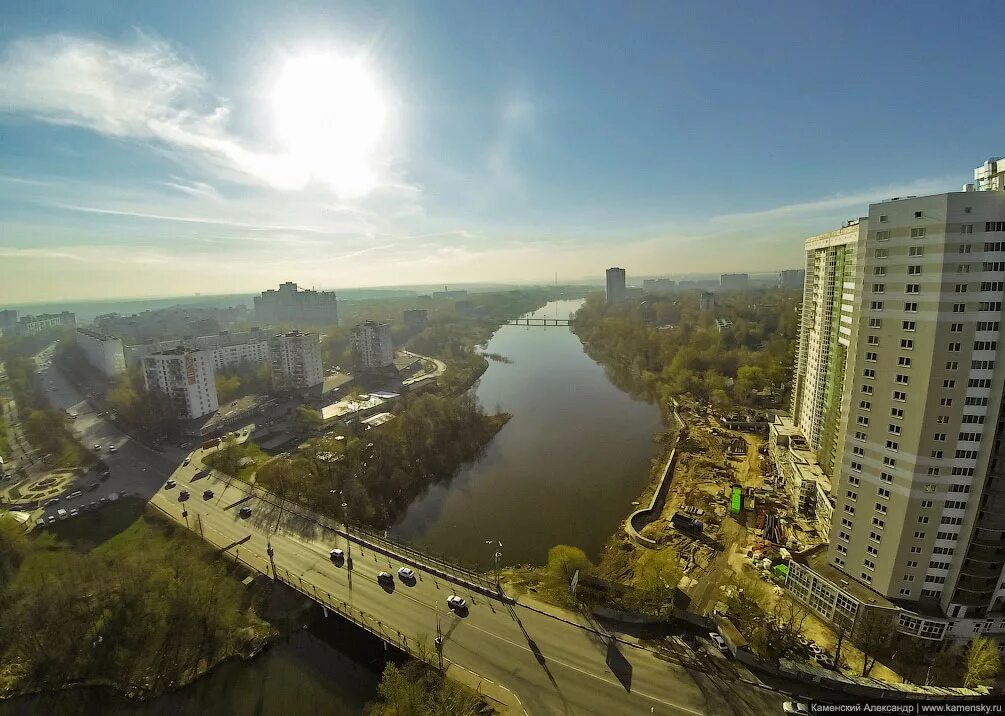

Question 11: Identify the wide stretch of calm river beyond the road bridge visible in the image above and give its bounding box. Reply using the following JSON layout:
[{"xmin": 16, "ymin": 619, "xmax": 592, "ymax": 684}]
[{"xmin": 391, "ymin": 301, "xmax": 661, "ymax": 569}]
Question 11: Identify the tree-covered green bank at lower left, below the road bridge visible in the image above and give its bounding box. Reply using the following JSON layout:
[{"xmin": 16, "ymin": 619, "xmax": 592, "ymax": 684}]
[{"xmin": 0, "ymin": 500, "xmax": 283, "ymax": 697}]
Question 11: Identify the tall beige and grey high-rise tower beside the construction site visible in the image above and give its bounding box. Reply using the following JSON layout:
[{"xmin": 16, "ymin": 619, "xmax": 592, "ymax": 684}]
[{"xmin": 789, "ymin": 170, "xmax": 1005, "ymax": 641}]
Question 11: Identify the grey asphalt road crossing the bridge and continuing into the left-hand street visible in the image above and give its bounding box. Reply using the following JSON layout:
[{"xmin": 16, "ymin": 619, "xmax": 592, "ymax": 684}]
[{"xmin": 44, "ymin": 358, "xmax": 783, "ymax": 716}]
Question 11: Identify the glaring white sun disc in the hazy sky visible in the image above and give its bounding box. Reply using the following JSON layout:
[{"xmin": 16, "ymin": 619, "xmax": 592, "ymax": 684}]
[{"xmin": 272, "ymin": 53, "xmax": 387, "ymax": 197}]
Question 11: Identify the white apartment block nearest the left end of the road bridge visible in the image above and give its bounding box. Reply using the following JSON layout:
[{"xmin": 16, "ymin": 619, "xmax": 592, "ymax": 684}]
[{"xmin": 143, "ymin": 348, "xmax": 220, "ymax": 419}]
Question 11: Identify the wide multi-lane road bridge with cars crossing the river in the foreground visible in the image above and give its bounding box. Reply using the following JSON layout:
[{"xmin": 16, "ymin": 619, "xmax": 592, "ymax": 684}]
[{"xmin": 151, "ymin": 450, "xmax": 782, "ymax": 716}]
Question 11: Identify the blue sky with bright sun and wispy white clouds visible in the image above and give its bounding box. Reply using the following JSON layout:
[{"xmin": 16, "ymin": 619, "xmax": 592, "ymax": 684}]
[{"xmin": 0, "ymin": 0, "xmax": 1005, "ymax": 305}]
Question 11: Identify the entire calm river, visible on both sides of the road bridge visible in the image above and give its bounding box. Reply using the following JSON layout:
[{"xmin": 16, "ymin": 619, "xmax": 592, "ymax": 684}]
[{"xmin": 0, "ymin": 301, "xmax": 661, "ymax": 716}]
